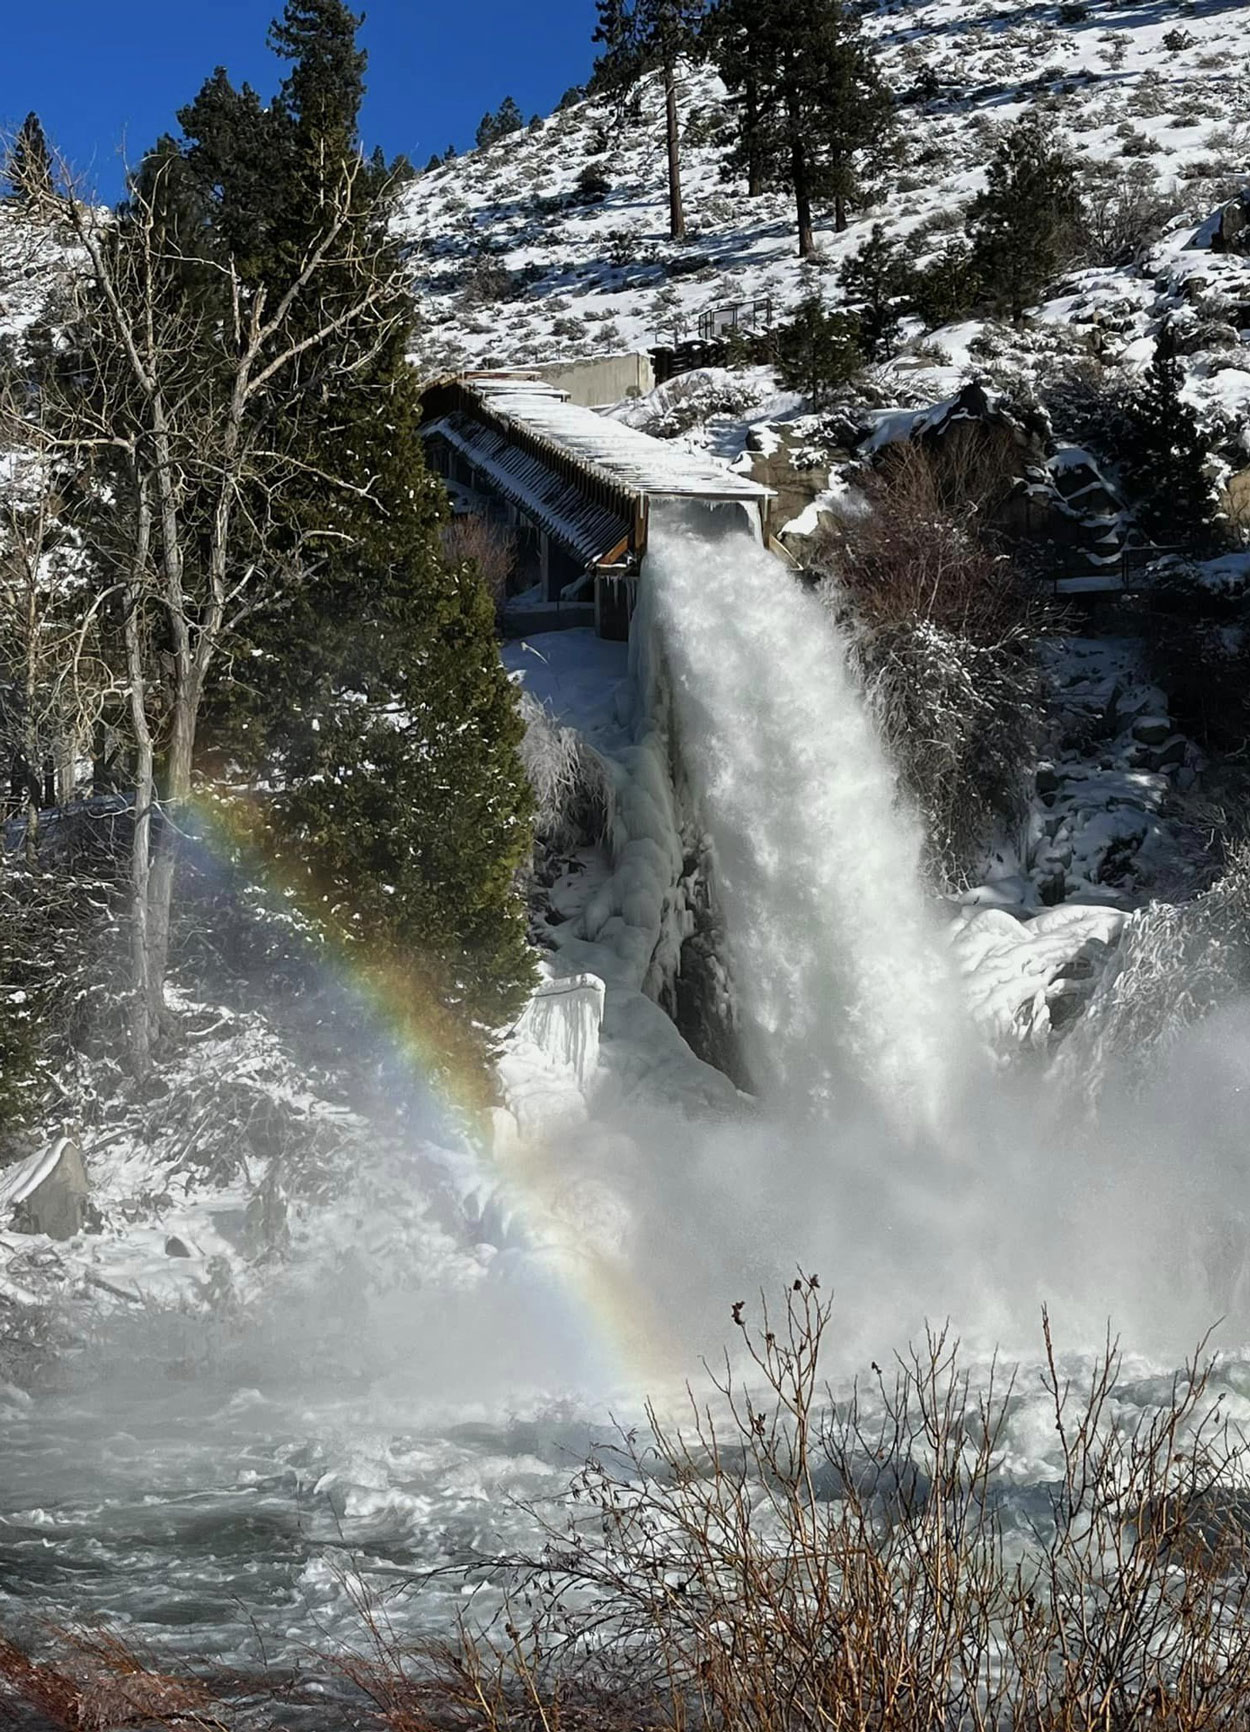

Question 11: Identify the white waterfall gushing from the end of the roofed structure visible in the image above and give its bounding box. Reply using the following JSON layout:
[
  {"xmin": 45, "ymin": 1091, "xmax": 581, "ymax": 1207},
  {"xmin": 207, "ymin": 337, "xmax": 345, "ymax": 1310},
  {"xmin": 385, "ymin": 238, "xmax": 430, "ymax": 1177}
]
[{"xmin": 635, "ymin": 506, "xmax": 971, "ymax": 1131}]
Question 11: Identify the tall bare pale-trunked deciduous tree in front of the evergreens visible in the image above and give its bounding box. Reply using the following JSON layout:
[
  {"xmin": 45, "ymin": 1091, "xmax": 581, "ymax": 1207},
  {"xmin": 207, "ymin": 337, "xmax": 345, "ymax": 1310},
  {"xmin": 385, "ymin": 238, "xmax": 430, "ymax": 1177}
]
[{"xmin": 0, "ymin": 159, "xmax": 413, "ymax": 1072}]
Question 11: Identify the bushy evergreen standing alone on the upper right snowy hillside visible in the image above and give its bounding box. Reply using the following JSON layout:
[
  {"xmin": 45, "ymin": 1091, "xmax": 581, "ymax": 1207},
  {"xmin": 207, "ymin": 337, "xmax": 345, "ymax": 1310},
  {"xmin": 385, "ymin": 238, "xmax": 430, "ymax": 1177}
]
[{"xmin": 968, "ymin": 113, "xmax": 1080, "ymax": 324}]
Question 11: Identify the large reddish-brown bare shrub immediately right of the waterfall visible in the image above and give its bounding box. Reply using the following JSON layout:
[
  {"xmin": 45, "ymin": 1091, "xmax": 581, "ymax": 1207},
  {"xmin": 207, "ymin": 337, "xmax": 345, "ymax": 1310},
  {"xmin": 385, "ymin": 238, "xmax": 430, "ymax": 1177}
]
[{"xmin": 810, "ymin": 438, "xmax": 1041, "ymax": 887}]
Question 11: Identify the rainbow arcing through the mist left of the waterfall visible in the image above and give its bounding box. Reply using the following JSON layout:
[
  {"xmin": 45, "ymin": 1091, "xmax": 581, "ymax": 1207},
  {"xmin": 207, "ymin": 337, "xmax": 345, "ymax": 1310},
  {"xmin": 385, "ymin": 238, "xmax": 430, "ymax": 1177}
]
[{"xmin": 182, "ymin": 792, "xmax": 677, "ymax": 1394}]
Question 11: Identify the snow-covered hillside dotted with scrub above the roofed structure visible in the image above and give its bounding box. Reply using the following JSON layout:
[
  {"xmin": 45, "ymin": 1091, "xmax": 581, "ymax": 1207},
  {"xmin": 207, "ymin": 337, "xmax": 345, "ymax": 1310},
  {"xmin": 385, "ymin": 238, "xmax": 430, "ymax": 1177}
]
[{"xmin": 402, "ymin": 0, "xmax": 1250, "ymax": 456}]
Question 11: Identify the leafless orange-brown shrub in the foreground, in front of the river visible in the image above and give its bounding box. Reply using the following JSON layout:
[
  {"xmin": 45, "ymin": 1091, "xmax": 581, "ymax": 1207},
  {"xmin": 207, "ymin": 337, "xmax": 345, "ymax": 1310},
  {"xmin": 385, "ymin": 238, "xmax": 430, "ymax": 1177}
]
[{"xmin": 322, "ymin": 1278, "xmax": 1250, "ymax": 1732}]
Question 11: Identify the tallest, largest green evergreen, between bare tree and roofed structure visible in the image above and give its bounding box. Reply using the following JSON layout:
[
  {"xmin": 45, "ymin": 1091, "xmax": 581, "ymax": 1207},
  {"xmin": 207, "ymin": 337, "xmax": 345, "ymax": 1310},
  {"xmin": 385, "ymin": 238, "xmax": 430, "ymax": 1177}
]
[{"xmin": 168, "ymin": 0, "xmax": 532, "ymax": 1027}]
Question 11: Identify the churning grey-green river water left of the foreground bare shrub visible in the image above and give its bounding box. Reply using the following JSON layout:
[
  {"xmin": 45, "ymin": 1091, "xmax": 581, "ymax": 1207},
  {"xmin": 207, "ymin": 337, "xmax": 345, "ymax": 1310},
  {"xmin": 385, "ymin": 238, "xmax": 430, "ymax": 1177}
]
[{"xmin": 0, "ymin": 1337, "xmax": 592, "ymax": 1668}]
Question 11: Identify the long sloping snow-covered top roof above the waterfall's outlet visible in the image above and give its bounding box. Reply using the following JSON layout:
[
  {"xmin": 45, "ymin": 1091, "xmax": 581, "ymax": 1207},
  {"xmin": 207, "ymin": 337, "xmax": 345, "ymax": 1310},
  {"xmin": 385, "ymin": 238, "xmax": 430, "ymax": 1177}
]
[{"xmin": 462, "ymin": 372, "xmax": 772, "ymax": 501}]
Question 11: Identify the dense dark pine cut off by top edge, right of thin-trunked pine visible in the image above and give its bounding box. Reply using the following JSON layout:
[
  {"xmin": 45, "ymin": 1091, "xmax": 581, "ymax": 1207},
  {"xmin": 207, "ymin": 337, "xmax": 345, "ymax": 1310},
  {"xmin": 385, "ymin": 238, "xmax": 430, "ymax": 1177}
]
[{"xmin": 712, "ymin": 0, "xmax": 893, "ymax": 258}]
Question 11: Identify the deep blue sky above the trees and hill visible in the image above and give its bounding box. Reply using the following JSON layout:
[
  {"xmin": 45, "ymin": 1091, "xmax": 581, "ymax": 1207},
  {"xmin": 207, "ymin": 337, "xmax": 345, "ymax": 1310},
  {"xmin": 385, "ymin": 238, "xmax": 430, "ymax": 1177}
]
[{"xmin": 0, "ymin": 0, "xmax": 594, "ymax": 199}]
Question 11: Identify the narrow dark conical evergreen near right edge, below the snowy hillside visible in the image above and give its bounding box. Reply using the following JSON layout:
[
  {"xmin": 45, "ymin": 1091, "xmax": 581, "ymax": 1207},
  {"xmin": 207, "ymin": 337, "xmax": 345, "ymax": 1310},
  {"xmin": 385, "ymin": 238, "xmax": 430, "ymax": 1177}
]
[{"xmin": 1122, "ymin": 320, "xmax": 1214, "ymax": 546}]
